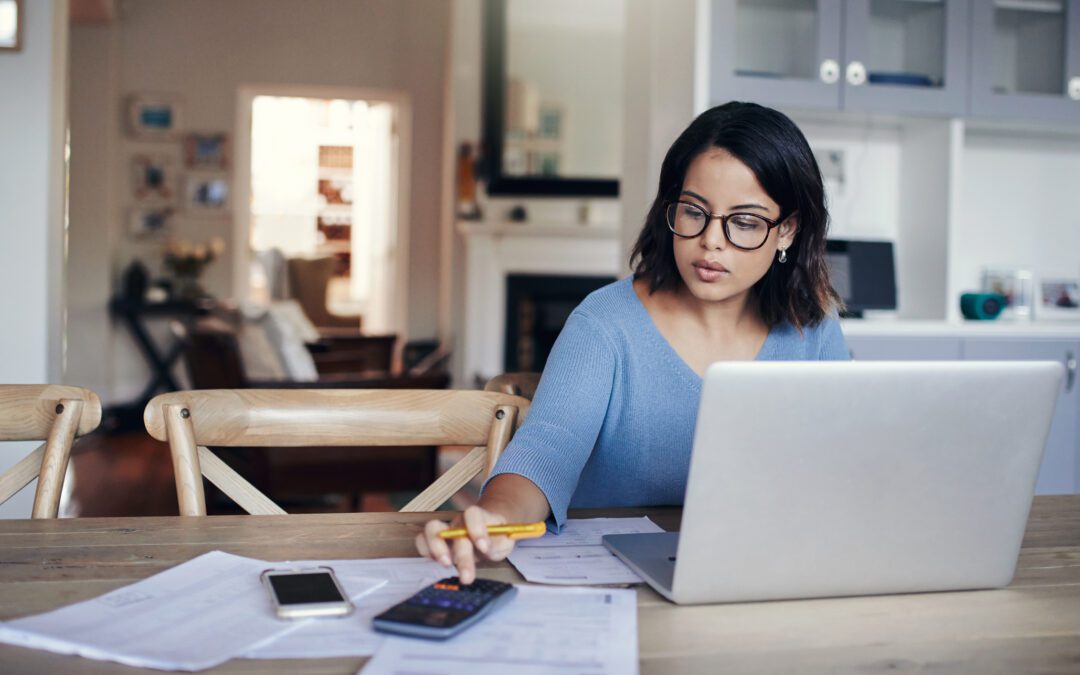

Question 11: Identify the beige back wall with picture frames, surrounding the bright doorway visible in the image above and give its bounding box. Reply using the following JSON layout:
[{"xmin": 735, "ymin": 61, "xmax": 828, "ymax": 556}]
[{"xmin": 71, "ymin": 0, "xmax": 449, "ymax": 402}]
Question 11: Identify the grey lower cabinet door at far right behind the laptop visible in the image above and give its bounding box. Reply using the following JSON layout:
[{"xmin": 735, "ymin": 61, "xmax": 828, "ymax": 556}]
[{"xmin": 963, "ymin": 338, "xmax": 1080, "ymax": 495}]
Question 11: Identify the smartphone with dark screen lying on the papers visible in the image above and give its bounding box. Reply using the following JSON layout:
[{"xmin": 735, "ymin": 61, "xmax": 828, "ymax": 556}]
[{"xmin": 260, "ymin": 567, "xmax": 352, "ymax": 619}]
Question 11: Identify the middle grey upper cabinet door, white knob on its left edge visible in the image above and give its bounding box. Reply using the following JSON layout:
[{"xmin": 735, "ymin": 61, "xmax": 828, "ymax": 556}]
[{"xmin": 840, "ymin": 0, "xmax": 971, "ymax": 117}]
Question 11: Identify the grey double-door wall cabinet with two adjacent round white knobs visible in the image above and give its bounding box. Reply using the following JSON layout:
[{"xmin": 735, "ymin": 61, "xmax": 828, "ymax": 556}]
[{"xmin": 711, "ymin": 0, "xmax": 970, "ymax": 117}]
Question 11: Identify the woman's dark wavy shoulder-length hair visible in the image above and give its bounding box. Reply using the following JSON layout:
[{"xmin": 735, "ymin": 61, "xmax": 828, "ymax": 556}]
[{"xmin": 630, "ymin": 102, "xmax": 842, "ymax": 329}]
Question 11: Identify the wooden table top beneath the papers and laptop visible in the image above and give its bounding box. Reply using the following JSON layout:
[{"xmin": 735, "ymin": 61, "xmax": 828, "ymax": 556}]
[{"xmin": 0, "ymin": 495, "xmax": 1080, "ymax": 675}]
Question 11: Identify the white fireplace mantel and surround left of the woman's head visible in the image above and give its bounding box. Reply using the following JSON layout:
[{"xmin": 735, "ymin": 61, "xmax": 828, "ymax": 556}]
[{"xmin": 457, "ymin": 221, "xmax": 629, "ymax": 386}]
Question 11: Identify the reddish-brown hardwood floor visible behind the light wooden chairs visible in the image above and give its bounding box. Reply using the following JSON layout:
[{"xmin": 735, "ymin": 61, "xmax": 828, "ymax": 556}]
[{"xmin": 60, "ymin": 431, "xmax": 480, "ymax": 517}]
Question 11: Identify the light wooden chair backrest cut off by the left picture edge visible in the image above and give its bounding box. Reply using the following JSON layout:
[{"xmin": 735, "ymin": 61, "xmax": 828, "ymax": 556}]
[{"xmin": 0, "ymin": 384, "xmax": 102, "ymax": 518}]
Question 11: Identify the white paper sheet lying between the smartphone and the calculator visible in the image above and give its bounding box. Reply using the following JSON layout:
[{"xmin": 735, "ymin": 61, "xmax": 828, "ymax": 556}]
[{"xmin": 244, "ymin": 557, "xmax": 457, "ymax": 659}]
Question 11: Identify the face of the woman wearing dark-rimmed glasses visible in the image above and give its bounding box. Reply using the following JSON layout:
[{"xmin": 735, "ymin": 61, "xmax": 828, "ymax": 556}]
[{"xmin": 672, "ymin": 148, "xmax": 797, "ymax": 302}]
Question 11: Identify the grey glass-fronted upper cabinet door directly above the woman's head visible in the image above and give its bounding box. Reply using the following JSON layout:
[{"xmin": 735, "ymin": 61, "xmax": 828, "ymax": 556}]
[{"xmin": 712, "ymin": 0, "xmax": 842, "ymax": 110}]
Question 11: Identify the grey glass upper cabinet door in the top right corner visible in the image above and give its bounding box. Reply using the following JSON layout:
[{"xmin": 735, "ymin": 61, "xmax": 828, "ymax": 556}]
[{"xmin": 969, "ymin": 0, "xmax": 1080, "ymax": 123}]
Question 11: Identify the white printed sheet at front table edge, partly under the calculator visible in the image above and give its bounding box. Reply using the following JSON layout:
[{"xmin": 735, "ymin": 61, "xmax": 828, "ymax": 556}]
[{"xmin": 362, "ymin": 585, "xmax": 637, "ymax": 675}]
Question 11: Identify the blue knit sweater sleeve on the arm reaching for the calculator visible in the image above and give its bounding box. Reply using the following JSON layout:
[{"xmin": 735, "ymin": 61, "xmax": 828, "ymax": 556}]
[{"xmin": 485, "ymin": 308, "xmax": 617, "ymax": 531}]
